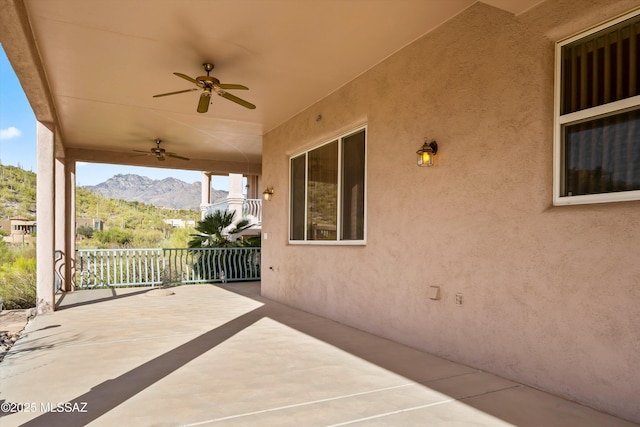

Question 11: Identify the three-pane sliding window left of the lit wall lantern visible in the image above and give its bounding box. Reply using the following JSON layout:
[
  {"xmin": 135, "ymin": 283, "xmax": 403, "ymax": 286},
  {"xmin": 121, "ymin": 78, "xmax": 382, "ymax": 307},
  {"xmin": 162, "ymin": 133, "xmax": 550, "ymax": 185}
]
[{"xmin": 289, "ymin": 128, "xmax": 366, "ymax": 244}]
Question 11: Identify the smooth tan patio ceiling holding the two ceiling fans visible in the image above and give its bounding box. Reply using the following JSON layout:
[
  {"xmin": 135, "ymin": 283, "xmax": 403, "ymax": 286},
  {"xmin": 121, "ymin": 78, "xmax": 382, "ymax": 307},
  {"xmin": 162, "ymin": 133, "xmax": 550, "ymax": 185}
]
[{"xmin": 0, "ymin": 0, "xmax": 540, "ymax": 173}]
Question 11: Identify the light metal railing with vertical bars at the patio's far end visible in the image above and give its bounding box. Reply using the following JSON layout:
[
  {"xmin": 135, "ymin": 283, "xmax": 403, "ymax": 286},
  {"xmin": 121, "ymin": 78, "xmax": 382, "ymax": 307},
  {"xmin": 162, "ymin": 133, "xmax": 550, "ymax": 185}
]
[{"xmin": 76, "ymin": 248, "xmax": 260, "ymax": 288}]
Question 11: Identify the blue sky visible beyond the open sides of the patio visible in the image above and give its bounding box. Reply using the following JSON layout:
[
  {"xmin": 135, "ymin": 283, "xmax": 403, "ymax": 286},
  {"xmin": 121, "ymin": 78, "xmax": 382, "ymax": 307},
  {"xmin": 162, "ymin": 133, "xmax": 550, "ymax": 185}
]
[{"xmin": 0, "ymin": 45, "xmax": 229, "ymax": 190}]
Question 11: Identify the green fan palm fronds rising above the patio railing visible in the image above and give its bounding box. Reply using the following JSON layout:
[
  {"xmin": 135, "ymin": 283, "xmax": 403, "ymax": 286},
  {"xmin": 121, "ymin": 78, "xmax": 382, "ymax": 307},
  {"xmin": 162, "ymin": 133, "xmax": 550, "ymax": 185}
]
[{"xmin": 189, "ymin": 211, "xmax": 253, "ymax": 248}]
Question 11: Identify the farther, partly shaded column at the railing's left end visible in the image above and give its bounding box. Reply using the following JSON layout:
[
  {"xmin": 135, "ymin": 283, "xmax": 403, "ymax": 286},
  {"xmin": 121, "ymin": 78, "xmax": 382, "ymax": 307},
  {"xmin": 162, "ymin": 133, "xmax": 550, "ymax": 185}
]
[{"xmin": 64, "ymin": 160, "xmax": 76, "ymax": 292}]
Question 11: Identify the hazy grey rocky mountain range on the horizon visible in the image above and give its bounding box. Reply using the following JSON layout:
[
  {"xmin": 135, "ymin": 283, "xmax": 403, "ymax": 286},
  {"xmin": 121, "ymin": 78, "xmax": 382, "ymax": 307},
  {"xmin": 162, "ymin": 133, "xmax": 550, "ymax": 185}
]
[{"xmin": 84, "ymin": 174, "xmax": 227, "ymax": 210}]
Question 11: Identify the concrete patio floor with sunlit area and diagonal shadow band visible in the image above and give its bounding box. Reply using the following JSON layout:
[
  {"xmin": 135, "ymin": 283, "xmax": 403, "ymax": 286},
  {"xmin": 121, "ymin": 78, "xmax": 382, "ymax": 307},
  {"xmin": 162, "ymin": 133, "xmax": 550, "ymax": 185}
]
[{"xmin": 0, "ymin": 283, "xmax": 637, "ymax": 427}]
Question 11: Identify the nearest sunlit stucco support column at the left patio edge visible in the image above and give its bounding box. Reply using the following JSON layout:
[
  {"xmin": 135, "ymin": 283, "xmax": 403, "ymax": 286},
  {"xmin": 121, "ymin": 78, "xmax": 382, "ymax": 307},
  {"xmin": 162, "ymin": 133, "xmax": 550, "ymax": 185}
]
[{"xmin": 36, "ymin": 122, "xmax": 55, "ymax": 314}]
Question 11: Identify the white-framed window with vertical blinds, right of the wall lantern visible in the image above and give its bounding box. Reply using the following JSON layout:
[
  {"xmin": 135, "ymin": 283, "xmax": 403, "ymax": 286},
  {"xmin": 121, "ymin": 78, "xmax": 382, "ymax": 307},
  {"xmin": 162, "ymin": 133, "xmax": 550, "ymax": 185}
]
[{"xmin": 554, "ymin": 11, "xmax": 640, "ymax": 205}]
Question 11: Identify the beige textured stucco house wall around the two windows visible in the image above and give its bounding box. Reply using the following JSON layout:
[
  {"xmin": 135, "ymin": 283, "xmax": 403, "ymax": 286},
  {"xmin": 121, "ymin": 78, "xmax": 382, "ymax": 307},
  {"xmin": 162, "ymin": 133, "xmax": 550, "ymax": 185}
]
[{"xmin": 262, "ymin": 0, "xmax": 640, "ymax": 421}]
